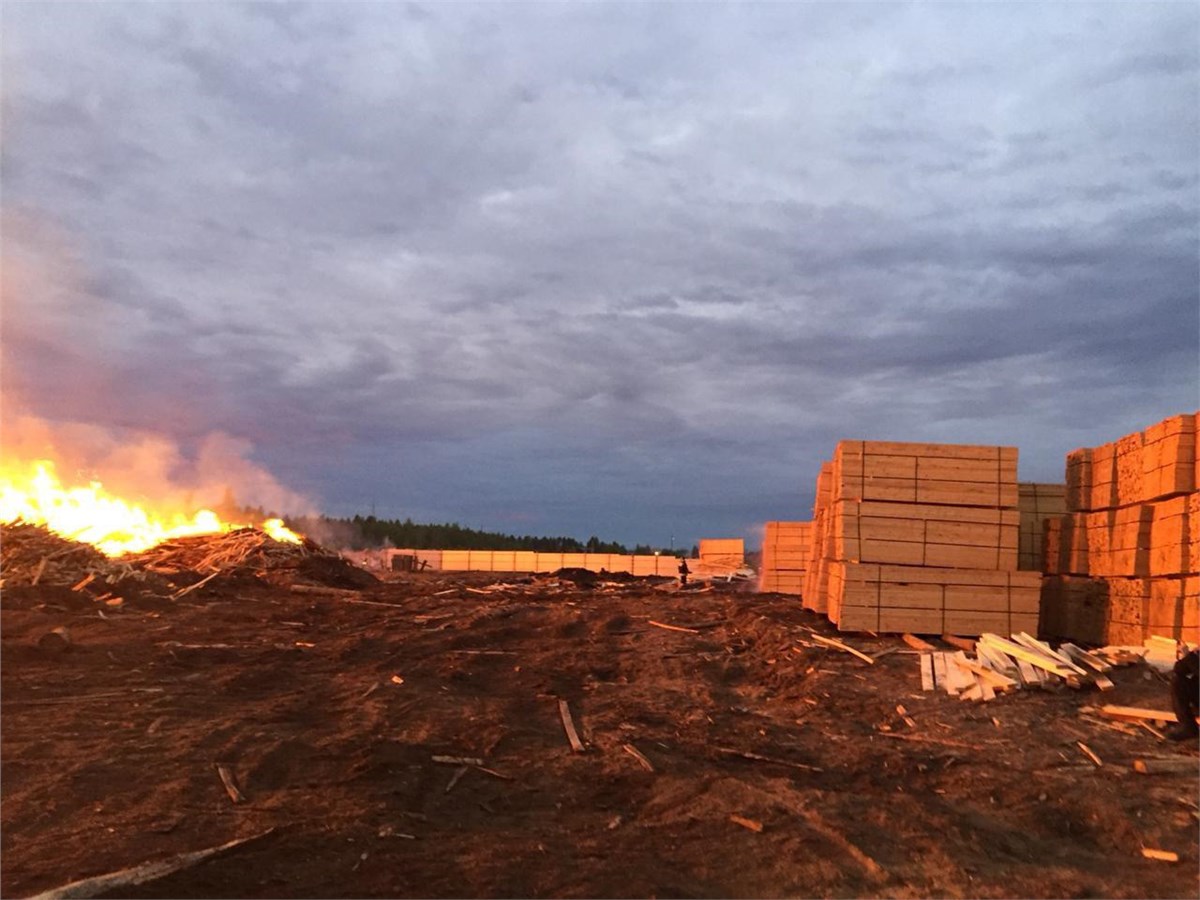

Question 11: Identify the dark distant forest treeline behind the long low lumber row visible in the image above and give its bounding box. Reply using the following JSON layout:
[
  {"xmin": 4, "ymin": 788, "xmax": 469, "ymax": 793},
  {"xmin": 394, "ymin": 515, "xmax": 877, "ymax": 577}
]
[{"xmin": 287, "ymin": 516, "xmax": 697, "ymax": 556}]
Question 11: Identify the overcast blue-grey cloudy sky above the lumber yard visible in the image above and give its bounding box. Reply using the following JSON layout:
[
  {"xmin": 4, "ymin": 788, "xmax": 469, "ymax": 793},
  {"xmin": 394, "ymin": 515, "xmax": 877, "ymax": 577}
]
[{"xmin": 0, "ymin": 0, "xmax": 1200, "ymax": 546}]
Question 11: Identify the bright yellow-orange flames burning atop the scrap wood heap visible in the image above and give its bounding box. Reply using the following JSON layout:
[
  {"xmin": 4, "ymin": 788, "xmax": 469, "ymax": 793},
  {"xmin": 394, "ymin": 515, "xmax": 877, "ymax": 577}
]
[{"xmin": 0, "ymin": 460, "xmax": 301, "ymax": 557}]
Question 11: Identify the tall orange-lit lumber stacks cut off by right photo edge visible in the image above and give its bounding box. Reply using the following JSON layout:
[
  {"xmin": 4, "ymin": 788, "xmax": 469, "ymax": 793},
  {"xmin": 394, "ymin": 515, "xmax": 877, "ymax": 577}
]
[{"xmin": 1042, "ymin": 414, "xmax": 1200, "ymax": 644}]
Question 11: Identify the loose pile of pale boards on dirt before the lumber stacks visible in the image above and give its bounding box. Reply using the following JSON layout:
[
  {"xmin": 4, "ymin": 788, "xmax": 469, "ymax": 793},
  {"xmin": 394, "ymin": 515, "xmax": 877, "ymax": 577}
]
[{"xmin": 918, "ymin": 632, "xmax": 1144, "ymax": 701}]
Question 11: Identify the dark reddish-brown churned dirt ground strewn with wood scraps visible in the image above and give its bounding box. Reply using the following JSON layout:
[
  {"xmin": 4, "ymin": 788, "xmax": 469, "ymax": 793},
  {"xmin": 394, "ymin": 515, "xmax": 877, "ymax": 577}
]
[{"xmin": 0, "ymin": 574, "xmax": 1200, "ymax": 898}]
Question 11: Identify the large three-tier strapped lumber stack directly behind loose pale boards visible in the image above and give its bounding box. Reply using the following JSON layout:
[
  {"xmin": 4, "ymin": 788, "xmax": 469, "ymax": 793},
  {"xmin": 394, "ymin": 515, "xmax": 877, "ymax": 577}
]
[{"xmin": 804, "ymin": 440, "xmax": 1042, "ymax": 635}]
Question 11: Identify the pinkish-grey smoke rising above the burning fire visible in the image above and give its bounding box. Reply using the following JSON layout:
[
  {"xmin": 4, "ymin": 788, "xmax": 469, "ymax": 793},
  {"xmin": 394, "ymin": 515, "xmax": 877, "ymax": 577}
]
[{"xmin": 0, "ymin": 208, "xmax": 314, "ymax": 515}]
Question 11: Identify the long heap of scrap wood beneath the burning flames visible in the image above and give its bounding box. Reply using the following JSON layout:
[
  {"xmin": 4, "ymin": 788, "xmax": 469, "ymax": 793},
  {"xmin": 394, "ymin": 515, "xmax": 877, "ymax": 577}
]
[{"xmin": 0, "ymin": 522, "xmax": 376, "ymax": 599}]
